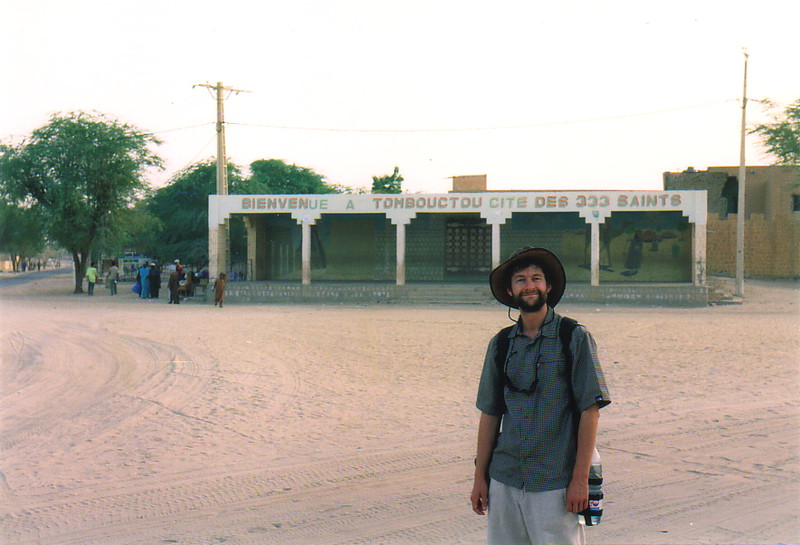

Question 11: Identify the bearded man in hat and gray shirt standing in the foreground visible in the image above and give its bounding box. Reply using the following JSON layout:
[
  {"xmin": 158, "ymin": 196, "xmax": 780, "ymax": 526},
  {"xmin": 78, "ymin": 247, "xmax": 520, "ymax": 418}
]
[{"xmin": 471, "ymin": 248, "xmax": 610, "ymax": 545}]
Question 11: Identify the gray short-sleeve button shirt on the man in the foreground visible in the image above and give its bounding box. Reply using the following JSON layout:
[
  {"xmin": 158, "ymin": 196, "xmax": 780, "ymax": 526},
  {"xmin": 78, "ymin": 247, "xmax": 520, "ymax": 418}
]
[{"xmin": 476, "ymin": 309, "xmax": 611, "ymax": 492}]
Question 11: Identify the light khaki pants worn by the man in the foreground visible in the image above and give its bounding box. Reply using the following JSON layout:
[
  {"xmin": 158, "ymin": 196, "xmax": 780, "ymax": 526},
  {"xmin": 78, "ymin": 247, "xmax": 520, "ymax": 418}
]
[{"xmin": 486, "ymin": 479, "xmax": 586, "ymax": 545}]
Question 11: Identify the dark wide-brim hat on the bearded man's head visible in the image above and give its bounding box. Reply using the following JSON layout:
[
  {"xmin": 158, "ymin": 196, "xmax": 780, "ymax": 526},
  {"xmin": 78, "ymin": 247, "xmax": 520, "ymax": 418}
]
[{"xmin": 489, "ymin": 247, "xmax": 567, "ymax": 308}]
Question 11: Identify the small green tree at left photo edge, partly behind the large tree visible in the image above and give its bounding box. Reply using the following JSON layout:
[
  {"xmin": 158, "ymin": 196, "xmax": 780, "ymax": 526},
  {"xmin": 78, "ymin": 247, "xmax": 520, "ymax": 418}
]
[{"xmin": 0, "ymin": 203, "xmax": 45, "ymax": 271}]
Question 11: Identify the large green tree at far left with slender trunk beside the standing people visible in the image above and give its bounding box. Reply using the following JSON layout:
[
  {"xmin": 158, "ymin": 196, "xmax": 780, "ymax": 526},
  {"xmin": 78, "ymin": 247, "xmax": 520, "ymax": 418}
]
[{"xmin": 0, "ymin": 112, "xmax": 161, "ymax": 293}]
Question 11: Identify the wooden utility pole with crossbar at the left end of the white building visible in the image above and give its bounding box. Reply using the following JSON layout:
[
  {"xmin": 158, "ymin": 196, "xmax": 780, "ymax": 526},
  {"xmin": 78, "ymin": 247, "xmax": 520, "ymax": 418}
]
[{"xmin": 192, "ymin": 81, "xmax": 248, "ymax": 279}]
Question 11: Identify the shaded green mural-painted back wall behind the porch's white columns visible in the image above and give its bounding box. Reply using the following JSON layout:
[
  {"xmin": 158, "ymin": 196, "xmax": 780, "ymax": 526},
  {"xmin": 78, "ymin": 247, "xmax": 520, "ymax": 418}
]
[{"xmin": 248, "ymin": 211, "xmax": 692, "ymax": 283}]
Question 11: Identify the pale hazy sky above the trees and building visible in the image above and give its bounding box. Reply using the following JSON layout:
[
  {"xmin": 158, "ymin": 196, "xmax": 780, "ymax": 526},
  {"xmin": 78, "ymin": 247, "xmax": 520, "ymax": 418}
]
[{"xmin": 0, "ymin": 0, "xmax": 800, "ymax": 193}]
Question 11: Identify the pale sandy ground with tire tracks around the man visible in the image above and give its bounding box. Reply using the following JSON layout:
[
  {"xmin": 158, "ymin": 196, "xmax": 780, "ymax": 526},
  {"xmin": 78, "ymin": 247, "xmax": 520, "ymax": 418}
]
[{"xmin": 0, "ymin": 268, "xmax": 800, "ymax": 545}]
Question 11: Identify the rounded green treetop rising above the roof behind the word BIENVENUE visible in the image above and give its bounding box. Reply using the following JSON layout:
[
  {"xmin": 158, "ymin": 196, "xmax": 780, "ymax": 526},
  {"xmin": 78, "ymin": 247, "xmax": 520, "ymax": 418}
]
[{"xmin": 247, "ymin": 159, "xmax": 343, "ymax": 195}]
